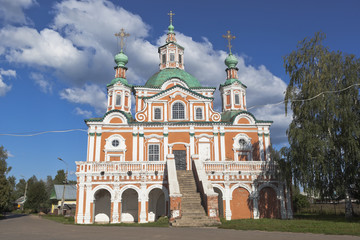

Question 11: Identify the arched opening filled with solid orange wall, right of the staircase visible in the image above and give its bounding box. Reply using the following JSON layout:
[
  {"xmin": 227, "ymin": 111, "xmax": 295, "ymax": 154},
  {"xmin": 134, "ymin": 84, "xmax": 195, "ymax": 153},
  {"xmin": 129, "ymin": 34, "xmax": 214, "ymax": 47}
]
[{"xmin": 230, "ymin": 187, "xmax": 252, "ymax": 219}]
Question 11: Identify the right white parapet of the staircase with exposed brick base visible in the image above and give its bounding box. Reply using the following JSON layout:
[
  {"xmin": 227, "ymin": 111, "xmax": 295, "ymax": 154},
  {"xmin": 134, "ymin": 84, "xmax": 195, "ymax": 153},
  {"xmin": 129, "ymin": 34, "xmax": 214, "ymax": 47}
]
[{"xmin": 191, "ymin": 154, "xmax": 219, "ymax": 221}]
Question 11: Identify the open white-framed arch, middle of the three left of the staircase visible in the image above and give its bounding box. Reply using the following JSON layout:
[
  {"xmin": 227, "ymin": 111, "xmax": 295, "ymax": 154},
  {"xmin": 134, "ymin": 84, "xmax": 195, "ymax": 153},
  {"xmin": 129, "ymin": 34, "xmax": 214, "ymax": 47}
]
[{"xmin": 121, "ymin": 189, "xmax": 139, "ymax": 222}]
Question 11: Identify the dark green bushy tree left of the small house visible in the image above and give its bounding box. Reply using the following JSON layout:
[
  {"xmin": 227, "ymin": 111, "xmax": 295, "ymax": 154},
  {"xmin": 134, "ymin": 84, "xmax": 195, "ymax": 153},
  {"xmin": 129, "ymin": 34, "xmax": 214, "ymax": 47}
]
[{"xmin": 24, "ymin": 176, "xmax": 49, "ymax": 212}]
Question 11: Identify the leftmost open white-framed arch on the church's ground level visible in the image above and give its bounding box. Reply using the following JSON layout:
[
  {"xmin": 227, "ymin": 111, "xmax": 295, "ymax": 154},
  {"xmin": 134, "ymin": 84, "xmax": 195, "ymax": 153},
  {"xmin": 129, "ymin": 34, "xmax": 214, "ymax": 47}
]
[{"xmin": 94, "ymin": 189, "xmax": 111, "ymax": 223}]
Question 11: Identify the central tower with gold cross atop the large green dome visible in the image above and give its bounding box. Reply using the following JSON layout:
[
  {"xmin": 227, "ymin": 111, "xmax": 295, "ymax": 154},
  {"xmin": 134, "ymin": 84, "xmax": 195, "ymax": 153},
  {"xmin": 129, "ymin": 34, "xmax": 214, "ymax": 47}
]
[{"xmin": 158, "ymin": 11, "xmax": 184, "ymax": 70}]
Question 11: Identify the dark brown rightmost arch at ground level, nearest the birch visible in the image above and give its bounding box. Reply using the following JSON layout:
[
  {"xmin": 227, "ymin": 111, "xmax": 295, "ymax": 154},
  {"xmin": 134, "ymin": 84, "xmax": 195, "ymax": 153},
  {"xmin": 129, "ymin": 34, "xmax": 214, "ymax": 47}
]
[{"xmin": 259, "ymin": 187, "xmax": 280, "ymax": 218}]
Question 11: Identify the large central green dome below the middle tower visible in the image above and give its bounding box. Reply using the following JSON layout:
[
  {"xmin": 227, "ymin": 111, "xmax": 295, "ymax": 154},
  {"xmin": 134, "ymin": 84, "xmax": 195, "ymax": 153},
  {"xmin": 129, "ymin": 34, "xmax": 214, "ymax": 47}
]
[{"xmin": 145, "ymin": 68, "xmax": 201, "ymax": 88}]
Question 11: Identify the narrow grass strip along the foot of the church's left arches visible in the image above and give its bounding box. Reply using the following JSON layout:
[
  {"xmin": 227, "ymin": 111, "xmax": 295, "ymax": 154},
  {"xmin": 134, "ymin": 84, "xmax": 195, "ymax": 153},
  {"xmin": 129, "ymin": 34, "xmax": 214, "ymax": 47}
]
[{"xmin": 42, "ymin": 215, "xmax": 169, "ymax": 227}]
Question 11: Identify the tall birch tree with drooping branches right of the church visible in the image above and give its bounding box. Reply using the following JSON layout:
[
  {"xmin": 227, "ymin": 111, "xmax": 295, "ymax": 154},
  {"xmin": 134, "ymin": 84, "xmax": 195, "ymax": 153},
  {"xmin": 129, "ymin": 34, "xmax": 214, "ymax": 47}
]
[{"xmin": 284, "ymin": 33, "xmax": 360, "ymax": 218}]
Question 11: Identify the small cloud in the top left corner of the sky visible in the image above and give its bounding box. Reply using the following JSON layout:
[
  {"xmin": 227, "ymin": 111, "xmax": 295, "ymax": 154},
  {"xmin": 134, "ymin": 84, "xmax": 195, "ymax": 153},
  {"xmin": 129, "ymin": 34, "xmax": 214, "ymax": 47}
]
[{"xmin": 0, "ymin": 0, "xmax": 36, "ymax": 24}]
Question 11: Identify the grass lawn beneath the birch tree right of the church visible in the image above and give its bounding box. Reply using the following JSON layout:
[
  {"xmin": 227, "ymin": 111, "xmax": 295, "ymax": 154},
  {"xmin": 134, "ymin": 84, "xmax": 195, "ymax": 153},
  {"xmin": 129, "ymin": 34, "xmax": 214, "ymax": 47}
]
[{"xmin": 220, "ymin": 214, "xmax": 360, "ymax": 236}]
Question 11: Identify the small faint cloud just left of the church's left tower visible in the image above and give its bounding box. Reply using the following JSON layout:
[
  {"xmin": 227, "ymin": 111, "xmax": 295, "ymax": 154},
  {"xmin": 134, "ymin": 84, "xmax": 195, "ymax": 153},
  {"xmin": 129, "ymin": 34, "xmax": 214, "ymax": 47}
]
[{"xmin": 60, "ymin": 84, "xmax": 107, "ymax": 115}]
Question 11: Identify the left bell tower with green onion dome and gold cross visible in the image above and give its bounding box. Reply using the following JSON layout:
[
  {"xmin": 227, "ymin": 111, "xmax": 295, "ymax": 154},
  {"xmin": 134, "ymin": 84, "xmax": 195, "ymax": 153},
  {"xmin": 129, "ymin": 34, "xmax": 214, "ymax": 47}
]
[{"xmin": 107, "ymin": 29, "xmax": 132, "ymax": 113}]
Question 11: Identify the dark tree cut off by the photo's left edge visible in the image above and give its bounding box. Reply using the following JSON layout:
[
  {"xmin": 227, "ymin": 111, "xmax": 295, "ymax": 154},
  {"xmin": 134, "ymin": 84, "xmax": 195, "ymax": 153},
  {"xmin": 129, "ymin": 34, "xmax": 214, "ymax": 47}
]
[{"xmin": 0, "ymin": 146, "xmax": 12, "ymax": 212}]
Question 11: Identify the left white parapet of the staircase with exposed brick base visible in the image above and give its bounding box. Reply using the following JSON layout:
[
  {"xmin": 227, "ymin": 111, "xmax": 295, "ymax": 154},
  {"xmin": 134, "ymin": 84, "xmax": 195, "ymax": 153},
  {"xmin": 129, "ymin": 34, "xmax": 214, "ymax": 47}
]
[{"xmin": 166, "ymin": 154, "xmax": 182, "ymax": 222}]
